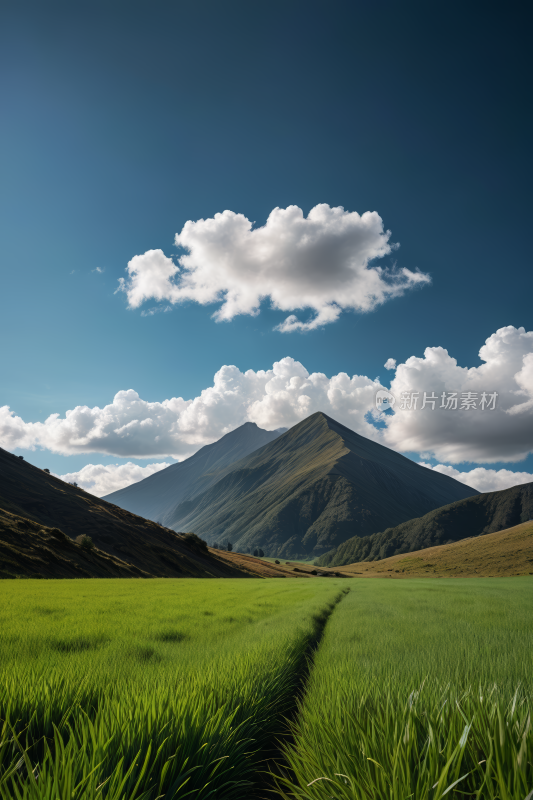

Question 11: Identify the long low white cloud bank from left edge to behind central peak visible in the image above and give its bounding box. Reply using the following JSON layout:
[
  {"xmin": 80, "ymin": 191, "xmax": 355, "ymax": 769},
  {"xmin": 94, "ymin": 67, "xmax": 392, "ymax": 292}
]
[{"xmin": 0, "ymin": 358, "xmax": 380, "ymax": 458}]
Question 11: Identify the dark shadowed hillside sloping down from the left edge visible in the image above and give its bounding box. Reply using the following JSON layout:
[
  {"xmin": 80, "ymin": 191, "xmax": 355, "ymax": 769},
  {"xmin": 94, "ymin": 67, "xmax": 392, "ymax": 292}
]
[{"xmin": 0, "ymin": 448, "xmax": 245, "ymax": 577}]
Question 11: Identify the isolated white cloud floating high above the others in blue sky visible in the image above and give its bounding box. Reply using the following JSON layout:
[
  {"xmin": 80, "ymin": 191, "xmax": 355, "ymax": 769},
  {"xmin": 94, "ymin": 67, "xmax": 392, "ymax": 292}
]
[{"xmin": 116, "ymin": 203, "xmax": 430, "ymax": 332}]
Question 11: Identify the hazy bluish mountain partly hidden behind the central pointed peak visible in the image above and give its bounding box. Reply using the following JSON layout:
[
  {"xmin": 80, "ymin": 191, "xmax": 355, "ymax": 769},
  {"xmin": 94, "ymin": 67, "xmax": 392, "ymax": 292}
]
[{"xmin": 103, "ymin": 422, "xmax": 286, "ymax": 522}]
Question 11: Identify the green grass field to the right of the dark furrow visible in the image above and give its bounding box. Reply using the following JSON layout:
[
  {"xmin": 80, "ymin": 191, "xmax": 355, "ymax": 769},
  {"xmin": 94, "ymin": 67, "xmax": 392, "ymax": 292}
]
[{"xmin": 279, "ymin": 578, "xmax": 533, "ymax": 800}]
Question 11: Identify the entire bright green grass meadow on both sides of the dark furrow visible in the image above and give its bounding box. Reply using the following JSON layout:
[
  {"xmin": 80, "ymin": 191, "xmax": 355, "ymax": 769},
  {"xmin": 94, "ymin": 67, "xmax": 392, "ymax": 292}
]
[{"xmin": 0, "ymin": 578, "xmax": 533, "ymax": 800}]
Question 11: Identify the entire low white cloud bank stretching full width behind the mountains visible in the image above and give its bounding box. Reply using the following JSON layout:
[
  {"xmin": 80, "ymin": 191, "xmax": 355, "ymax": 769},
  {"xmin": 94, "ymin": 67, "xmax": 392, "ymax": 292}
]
[{"xmin": 0, "ymin": 327, "xmax": 533, "ymax": 464}]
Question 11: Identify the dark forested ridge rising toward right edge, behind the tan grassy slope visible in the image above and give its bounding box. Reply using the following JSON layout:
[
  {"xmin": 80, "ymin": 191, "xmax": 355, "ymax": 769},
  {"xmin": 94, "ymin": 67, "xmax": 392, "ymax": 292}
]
[{"xmin": 317, "ymin": 478, "xmax": 533, "ymax": 567}]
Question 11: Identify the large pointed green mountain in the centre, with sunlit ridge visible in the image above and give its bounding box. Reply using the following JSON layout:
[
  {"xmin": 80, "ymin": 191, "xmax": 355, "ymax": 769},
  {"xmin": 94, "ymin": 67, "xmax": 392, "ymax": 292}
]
[{"xmin": 165, "ymin": 412, "xmax": 477, "ymax": 558}]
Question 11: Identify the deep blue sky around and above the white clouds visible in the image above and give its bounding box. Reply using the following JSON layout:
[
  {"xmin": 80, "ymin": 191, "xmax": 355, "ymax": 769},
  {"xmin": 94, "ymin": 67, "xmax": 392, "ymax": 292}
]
[{"xmin": 0, "ymin": 0, "xmax": 533, "ymax": 494}]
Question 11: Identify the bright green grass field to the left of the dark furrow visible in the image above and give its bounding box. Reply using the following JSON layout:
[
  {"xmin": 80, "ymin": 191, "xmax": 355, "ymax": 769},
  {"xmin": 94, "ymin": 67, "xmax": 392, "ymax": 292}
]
[{"xmin": 0, "ymin": 579, "xmax": 344, "ymax": 800}]
